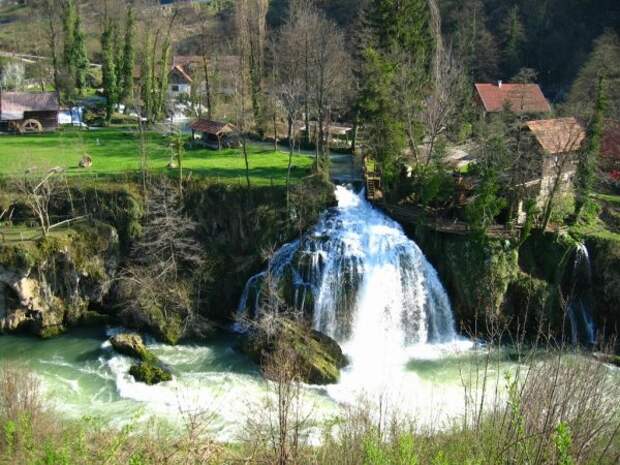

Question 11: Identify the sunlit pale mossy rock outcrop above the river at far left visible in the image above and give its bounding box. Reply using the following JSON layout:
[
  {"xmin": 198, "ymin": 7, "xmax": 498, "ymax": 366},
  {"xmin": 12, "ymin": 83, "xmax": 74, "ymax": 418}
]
[{"xmin": 0, "ymin": 223, "xmax": 119, "ymax": 337}]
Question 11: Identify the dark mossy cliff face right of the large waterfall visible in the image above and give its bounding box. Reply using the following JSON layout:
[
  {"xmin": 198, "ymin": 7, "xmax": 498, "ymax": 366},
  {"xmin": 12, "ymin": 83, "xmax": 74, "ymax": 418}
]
[{"xmin": 406, "ymin": 225, "xmax": 620, "ymax": 344}]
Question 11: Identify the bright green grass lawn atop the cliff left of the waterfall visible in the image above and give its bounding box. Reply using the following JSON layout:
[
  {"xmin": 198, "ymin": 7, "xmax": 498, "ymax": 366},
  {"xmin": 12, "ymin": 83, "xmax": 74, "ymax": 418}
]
[{"xmin": 0, "ymin": 128, "xmax": 312, "ymax": 185}]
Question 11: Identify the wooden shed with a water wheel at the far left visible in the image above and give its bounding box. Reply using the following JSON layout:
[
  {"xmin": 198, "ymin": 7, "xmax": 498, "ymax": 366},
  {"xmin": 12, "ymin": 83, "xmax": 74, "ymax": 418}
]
[{"xmin": 0, "ymin": 91, "xmax": 60, "ymax": 133}]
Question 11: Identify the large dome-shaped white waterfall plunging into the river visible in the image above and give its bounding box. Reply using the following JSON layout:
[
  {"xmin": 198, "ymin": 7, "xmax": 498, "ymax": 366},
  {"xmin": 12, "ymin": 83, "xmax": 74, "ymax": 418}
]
[{"xmin": 239, "ymin": 186, "xmax": 456, "ymax": 363}]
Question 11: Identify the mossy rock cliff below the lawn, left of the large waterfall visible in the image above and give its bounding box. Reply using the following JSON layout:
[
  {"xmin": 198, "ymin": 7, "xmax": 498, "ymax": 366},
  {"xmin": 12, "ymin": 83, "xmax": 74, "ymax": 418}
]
[{"xmin": 0, "ymin": 178, "xmax": 334, "ymax": 343}]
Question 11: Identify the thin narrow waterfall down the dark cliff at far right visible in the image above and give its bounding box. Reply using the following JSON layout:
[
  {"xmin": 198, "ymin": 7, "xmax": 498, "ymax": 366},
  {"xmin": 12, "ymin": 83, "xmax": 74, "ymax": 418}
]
[{"xmin": 567, "ymin": 243, "xmax": 596, "ymax": 345}]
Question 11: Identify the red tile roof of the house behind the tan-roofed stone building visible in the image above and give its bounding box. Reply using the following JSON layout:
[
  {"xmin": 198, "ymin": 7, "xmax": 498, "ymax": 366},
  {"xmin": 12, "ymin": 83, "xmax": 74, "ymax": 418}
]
[{"xmin": 475, "ymin": 81, "xmax": 551, "ymax": 114}]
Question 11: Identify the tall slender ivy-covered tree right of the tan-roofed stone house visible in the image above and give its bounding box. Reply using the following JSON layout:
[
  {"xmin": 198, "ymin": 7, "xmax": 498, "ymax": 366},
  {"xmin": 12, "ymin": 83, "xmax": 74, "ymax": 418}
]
[{"xmin": 575, "ymin": 76, "xmax": 607, "ymax": 216}]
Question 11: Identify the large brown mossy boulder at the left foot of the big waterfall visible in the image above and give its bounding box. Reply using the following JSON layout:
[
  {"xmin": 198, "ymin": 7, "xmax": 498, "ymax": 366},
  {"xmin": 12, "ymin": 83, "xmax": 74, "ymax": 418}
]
[{"xmin": 240, "ymin": 318, "xmax": 347, "ymax": 385}]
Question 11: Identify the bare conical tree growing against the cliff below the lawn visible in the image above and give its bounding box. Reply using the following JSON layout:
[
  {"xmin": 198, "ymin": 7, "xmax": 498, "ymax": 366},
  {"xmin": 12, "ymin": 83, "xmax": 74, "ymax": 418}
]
[{"xmin": 118, "ymin": 177, "xmax": 206, "ymax": 342}]
